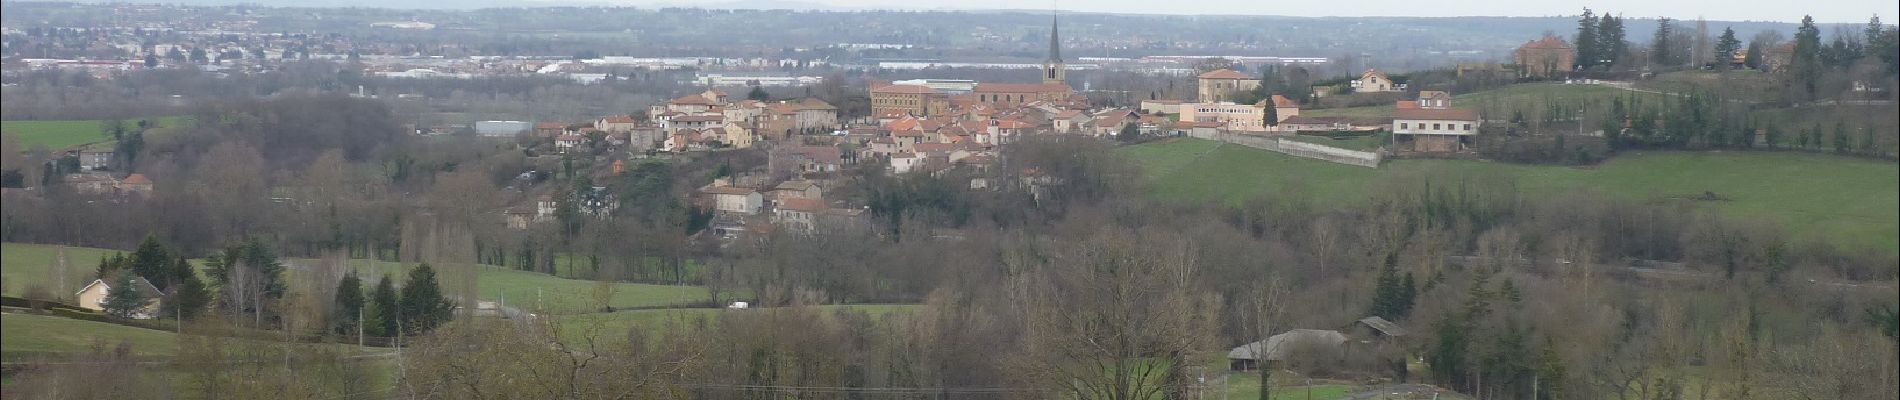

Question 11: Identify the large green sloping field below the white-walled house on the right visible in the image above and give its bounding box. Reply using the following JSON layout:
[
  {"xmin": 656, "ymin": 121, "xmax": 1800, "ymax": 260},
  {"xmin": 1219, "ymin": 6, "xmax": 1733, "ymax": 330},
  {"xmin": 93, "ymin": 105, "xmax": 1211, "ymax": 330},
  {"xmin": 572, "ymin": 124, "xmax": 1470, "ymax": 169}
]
[{"xmin": 1123, "ymin": 138, "xmax": 1900, "ymax": 250}]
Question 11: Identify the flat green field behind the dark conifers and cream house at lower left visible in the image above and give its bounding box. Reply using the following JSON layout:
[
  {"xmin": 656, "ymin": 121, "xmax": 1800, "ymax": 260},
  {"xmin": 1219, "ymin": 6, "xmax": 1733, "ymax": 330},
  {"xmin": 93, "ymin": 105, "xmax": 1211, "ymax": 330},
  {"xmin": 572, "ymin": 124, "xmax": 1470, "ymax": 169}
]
[{"xmin": 0, "ymin": 243, "xmax": 711, "ymax": 313}]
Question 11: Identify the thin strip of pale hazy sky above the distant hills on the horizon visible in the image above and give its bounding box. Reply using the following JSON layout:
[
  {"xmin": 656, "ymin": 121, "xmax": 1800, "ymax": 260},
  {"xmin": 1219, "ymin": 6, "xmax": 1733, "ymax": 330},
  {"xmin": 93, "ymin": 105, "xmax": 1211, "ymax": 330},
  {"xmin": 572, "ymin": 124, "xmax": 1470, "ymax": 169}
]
[{"xmin": 615, "ymin": 0, "xmax": 1900, "ymax": 25}]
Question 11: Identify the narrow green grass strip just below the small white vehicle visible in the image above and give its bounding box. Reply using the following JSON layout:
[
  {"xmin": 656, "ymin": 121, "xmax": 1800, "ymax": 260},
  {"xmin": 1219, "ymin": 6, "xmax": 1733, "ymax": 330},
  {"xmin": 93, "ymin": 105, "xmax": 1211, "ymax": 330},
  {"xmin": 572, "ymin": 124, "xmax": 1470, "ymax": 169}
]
[{"xmin": 555, "ymin": 303, "xmax": 923, "ymax": 341}]
